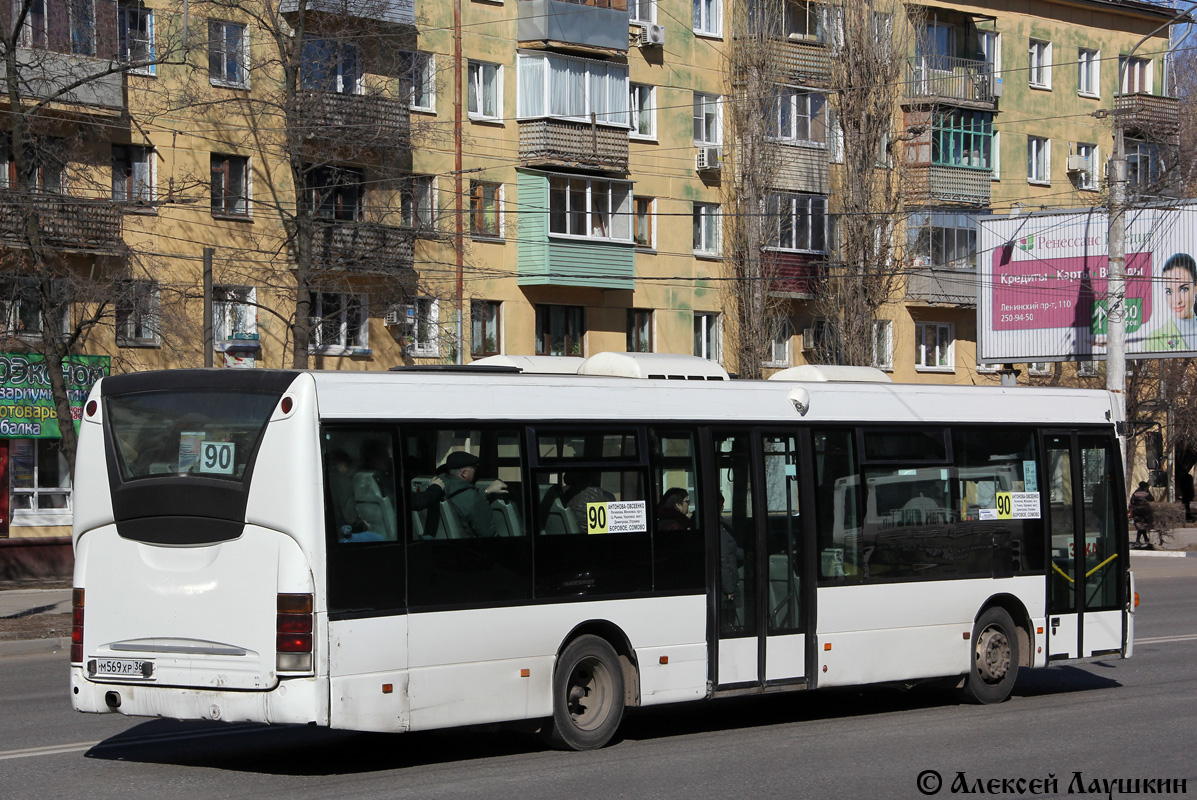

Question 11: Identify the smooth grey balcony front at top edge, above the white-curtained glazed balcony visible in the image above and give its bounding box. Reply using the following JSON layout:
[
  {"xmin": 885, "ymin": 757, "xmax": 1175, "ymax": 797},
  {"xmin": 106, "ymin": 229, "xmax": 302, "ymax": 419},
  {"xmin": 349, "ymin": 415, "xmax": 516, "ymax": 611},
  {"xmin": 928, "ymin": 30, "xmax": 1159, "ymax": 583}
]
[{"xmin": 516, "ymin": 0, "xmax": 628, "ymax": 53}]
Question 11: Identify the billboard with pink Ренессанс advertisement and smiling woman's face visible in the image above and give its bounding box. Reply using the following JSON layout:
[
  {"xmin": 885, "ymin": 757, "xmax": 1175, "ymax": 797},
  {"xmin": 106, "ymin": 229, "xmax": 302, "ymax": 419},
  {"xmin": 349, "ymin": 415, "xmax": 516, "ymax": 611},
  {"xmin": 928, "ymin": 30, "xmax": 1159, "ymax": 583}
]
[{"xmin": 977, "ymin": 202, "xmax": 1197, "ymax": 364}]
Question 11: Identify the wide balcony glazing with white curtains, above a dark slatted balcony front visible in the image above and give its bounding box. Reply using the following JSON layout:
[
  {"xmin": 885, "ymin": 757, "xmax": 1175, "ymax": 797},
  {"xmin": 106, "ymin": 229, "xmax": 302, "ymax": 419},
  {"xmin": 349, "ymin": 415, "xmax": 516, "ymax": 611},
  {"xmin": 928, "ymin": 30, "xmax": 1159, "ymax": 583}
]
[{"xmin": 516, "ymin": 53, "xmax": 632, "ymax": 127}]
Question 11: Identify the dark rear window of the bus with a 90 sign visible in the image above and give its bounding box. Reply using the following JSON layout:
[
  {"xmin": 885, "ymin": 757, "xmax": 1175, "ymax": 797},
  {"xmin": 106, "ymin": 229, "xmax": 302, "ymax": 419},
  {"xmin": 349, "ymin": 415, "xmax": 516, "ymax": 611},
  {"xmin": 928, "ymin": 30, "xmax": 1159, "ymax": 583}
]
[{"xmin": 105, "ymin": 392, "xmax": 279, "ymax": 480}]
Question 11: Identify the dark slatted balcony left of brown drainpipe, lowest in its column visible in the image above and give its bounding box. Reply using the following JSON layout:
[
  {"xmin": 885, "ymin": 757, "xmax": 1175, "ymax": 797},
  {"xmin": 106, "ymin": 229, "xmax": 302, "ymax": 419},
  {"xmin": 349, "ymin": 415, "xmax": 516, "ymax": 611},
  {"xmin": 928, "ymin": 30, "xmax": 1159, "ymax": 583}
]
[{"xmin": 312, "ymin": 219, "xmax": 415, "ymax": 280}]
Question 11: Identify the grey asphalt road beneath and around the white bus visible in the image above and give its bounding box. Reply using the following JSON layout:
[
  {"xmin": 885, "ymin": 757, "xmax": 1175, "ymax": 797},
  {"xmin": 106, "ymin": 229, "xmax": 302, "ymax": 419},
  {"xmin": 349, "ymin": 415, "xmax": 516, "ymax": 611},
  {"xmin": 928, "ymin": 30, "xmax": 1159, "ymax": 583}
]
[{"xmin": 0, "ymin": 558, "xmax": 1197, "ymax": 800}]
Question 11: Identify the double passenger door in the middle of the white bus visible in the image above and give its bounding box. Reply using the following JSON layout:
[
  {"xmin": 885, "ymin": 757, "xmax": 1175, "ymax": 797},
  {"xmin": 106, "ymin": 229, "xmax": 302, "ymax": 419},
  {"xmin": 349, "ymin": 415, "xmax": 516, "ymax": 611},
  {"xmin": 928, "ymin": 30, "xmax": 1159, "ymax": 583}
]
[{"xmin": 713, "ymin": 431, "xmax": 806, "ymax": 687}]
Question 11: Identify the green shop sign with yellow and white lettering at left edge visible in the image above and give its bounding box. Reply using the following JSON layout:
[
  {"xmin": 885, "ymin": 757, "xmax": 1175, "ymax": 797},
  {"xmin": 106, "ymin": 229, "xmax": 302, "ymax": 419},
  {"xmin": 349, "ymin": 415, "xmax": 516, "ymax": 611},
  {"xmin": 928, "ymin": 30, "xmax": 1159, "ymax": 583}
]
[{"xmin": 0, "ymin": 353, "xmax": 111, "ymax": 438}]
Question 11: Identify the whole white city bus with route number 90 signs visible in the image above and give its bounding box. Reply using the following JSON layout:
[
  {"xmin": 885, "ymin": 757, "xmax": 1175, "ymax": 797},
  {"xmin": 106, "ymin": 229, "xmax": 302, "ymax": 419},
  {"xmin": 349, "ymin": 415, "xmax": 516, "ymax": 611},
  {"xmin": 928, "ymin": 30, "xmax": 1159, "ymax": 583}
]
[{"xmin": 71, "ymin": 356, "xmax": 1134, "ymax": 749}]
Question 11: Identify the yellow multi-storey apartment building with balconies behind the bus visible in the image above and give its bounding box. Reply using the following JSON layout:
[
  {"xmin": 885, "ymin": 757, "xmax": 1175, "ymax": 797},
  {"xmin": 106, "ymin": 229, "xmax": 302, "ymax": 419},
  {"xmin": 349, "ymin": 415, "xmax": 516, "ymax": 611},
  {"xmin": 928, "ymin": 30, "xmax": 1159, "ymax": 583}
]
[{"xmin": 0, "ymin": 0, "xmax": 1177, "ymax": 535}]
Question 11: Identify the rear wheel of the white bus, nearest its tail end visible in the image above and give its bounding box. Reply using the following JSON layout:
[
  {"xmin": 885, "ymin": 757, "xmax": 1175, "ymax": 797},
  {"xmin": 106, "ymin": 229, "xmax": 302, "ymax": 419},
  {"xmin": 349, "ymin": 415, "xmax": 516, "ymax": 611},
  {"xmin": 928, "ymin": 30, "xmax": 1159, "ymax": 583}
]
[{"xmin": 545, "ymin": 635, "xmax": 624, "ymax": 750}]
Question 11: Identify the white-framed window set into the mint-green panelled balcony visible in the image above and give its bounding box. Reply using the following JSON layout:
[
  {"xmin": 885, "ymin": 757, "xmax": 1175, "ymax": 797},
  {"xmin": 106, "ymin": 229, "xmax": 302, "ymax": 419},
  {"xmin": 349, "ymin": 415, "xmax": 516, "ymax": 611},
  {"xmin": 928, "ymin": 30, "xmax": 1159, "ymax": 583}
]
[{"xmin": 548, "ymin": 175, "xmax": 632, "ymax": 242}]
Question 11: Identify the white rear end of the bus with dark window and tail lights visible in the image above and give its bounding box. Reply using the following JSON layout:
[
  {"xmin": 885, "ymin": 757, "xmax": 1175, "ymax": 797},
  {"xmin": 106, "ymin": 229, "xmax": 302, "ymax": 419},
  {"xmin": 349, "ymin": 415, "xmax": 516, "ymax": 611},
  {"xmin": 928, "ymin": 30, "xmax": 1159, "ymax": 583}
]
[{"xmin": 71, "ymin": 370, "xmax": 328, "ymax": 723}]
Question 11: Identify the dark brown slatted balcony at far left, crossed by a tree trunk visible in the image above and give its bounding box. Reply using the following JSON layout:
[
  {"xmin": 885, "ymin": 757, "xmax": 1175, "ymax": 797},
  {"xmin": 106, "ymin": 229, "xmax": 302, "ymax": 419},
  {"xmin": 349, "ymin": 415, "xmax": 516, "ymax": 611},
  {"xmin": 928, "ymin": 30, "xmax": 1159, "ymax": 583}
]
[{"xmin": 0, "ymin": 192, "xmax": 123, "ymax": 254}]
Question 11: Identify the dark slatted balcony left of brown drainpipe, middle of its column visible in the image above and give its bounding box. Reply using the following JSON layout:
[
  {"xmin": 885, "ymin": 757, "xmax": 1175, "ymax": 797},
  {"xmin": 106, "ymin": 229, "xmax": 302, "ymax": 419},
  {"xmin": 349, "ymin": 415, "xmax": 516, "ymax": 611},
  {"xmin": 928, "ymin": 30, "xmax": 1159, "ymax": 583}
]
[{"xmin": 296, "ymin": 89, "xmax": 412, "ymax": 150}]
